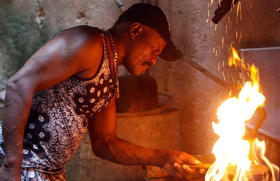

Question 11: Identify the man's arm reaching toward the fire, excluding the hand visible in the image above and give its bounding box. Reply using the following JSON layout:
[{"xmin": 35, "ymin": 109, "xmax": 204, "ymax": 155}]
[{"xmin": 88, "ymin": 94, "xmax": 168, "ymax": 167}]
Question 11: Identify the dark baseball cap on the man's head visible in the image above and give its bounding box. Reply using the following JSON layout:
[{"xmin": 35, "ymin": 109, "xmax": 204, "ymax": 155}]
[{"xmin": 117, "ymin": 3, "xmax": 183, "ymax": 61}]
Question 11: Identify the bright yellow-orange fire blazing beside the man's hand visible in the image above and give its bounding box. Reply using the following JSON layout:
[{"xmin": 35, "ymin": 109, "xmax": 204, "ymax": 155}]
[{"xmin": 205, "ymin": 49, "xmax": 279, "ymax": 181}]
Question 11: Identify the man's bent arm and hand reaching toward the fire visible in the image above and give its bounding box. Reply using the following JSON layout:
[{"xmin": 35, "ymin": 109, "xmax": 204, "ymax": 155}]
[{"xmin": 88, "ymin": 94, "xmax": 202, "ymax": 177}]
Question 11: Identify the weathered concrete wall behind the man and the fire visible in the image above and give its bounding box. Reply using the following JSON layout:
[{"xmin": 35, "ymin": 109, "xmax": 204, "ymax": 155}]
[{"xmin": 0, "ymin": 0, "xmax": 280, "ymax": 180}]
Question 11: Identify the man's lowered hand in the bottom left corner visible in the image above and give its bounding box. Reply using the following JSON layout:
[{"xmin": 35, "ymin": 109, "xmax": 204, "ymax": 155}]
[{"xmin": 0, "ymin": 165, "xmax": 20, "ymax": 181}]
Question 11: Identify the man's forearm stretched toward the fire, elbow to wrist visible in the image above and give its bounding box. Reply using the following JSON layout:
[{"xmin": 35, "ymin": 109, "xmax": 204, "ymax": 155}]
[{"xmin": 93, "ymin": 136, "xmax": 168, "ymax": 167}]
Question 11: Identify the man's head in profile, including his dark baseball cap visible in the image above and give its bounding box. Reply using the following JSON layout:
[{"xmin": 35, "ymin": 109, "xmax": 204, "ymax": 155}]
[{"xmin": 114, "ymin": 3, "xmax": 182, "ymax": 75}]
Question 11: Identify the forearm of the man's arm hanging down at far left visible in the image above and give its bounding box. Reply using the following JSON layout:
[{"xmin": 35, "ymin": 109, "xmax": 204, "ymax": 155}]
[{"xmin": 2, "ymin": 82, "xmax": 32, "ymax": 170}]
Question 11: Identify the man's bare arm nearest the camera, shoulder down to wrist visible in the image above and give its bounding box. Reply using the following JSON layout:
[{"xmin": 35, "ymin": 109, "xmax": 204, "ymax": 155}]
[{"xmin": 0, "ymin": 25, "xmax": 102, "ymax": 180}]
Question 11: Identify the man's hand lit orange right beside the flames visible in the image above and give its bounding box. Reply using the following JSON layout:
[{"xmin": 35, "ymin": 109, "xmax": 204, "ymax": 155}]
[{"xmin": 163, "ymin": 151, "xmax": 200, "ymax": 178}]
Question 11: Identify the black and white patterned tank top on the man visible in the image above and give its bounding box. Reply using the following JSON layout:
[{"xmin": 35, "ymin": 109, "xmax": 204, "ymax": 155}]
[{"xmin": 22, "ymin": 33, "xmax": 116, "ymax": 172}]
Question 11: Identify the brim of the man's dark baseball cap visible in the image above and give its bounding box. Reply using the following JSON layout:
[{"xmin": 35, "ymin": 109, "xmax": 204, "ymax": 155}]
[{"xmin": 159, "ymin": 41, "xmax": 183, "ymax": 61}]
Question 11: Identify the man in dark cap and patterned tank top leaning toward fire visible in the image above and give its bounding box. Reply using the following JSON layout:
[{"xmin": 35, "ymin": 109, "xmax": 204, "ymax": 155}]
[{"xmin": 0, "ymin": 4, "xmax": 199, "ymax": 181}]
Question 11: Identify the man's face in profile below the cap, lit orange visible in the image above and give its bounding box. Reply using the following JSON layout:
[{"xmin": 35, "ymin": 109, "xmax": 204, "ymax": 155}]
[{"xmin": 124, "ymin": 25, "xmax": 166, "ymax": 75}]
